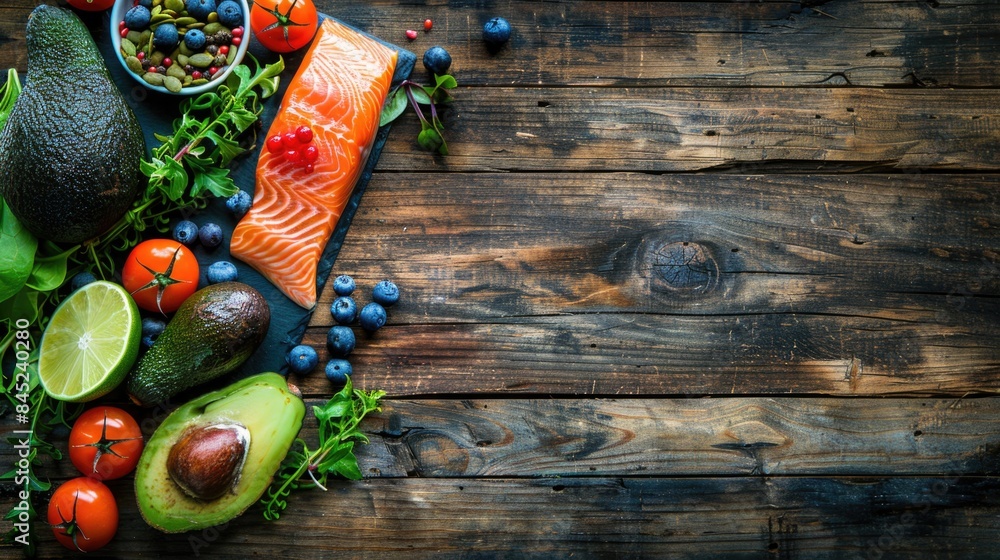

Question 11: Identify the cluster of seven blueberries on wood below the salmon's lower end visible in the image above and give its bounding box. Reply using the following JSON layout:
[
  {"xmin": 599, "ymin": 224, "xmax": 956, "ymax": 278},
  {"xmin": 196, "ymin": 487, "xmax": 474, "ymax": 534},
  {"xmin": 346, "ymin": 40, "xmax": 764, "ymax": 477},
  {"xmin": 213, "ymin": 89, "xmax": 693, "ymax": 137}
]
[{"xmin": 285, "ymin": 274, "xmax": 399, "ymax": 386}]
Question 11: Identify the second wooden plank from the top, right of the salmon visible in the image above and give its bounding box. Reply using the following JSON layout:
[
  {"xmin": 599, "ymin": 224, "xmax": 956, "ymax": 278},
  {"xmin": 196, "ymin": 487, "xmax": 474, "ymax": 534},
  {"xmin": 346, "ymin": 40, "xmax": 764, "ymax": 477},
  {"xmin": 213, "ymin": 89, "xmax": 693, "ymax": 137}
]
[{"xmin": 379, "ymin": 87, "xmax": 1000, "ymax": 172}]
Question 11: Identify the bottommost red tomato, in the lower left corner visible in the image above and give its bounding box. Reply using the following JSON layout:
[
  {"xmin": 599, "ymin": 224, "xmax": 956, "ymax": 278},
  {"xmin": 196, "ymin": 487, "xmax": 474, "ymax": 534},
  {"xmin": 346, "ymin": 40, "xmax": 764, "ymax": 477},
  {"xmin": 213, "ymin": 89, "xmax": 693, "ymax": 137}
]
[{"xmin": 48, "ymin": 476, "xmax": 118, "ymax": 552}]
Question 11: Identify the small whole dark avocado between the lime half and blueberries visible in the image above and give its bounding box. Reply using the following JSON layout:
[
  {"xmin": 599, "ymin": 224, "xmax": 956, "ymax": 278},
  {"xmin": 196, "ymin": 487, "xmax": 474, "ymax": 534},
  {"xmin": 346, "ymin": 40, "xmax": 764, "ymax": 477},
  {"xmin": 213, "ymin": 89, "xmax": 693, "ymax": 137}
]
[{"xmin": 128, "ymin": 282, "xmax": 271, "ymax": 406}]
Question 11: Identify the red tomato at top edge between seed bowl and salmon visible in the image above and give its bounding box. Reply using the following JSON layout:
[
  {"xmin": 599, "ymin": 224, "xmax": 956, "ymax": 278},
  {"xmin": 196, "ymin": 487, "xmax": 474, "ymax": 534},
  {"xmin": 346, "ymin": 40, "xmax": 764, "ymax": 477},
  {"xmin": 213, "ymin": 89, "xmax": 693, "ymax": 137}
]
[{"xmin": 250, "ymin": 0, "xmax": 319, "ymax": 53}]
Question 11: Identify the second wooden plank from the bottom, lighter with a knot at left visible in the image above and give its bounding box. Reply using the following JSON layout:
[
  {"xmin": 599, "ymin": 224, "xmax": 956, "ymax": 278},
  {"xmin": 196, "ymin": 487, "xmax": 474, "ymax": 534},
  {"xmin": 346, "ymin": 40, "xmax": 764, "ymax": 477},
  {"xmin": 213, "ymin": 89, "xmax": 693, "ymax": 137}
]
[{"xmin": 9, "ymin": 397, "xmax": 1000, "ymax": 479}]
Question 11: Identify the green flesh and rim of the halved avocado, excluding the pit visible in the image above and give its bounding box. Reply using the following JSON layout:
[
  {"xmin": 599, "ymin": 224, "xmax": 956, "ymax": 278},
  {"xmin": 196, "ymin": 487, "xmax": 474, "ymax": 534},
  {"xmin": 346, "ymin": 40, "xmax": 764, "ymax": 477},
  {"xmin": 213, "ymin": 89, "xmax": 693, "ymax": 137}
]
[{"xmin": 135, "ymin": 373, "xmax": 305, "ymax": 533}]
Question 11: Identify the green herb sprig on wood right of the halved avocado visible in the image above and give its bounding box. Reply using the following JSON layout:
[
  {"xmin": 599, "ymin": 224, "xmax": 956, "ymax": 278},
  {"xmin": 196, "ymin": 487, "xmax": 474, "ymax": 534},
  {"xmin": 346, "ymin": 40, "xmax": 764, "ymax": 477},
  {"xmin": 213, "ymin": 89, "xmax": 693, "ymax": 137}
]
[{"xmin": 261, "ymin": 378, "xmax": 385, "ymax": 521}]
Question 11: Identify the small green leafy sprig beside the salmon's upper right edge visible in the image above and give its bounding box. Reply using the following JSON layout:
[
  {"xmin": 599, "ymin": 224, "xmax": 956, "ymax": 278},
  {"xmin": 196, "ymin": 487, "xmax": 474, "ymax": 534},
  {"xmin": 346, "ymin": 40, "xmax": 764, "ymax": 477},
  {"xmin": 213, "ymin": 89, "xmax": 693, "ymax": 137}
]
[{"xmin": 379, "ymin": 74, "xmax": 458, "ymax": 156}]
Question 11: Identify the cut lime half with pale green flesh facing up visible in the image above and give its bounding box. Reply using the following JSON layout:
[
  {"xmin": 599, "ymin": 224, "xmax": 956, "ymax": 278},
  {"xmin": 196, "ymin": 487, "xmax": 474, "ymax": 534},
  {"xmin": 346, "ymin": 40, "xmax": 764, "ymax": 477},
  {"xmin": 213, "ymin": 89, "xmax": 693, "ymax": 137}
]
[{"xmin": 38, "ymin": 281, "xmax": 142, "ymax": 402}]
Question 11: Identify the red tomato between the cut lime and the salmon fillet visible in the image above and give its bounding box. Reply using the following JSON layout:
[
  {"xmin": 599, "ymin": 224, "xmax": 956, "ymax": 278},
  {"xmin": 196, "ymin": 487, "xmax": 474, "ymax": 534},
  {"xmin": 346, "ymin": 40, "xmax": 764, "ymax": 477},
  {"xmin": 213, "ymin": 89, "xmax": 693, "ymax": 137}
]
[{"xmin": 122, "ymin": 239, "xmax": 198, "ymax": 314}]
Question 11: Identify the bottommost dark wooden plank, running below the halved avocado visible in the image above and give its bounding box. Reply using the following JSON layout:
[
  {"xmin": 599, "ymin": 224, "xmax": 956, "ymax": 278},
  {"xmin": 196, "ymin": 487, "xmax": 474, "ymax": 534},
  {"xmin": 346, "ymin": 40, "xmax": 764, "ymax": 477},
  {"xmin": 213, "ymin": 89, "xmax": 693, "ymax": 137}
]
[{"xmin": 0, "ymin": 474, "xmax": 1000, "ymax": 559}]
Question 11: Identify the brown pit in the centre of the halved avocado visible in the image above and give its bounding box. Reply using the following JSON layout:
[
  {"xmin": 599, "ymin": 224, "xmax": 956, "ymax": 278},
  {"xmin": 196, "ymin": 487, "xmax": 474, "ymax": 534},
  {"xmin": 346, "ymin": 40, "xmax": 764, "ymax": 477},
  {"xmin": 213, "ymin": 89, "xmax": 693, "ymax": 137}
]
[{"xmin": 167, "ymin": 423, "xmax": 250, "ymax": 501}]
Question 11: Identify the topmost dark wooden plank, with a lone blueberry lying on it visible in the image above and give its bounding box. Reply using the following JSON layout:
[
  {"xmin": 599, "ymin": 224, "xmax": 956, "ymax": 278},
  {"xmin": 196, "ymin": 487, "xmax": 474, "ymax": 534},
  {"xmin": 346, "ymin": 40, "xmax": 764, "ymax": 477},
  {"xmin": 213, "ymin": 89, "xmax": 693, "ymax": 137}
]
[{"xmin": 0, "ymin": 0, "xmax": 1000, "ymax": 87}]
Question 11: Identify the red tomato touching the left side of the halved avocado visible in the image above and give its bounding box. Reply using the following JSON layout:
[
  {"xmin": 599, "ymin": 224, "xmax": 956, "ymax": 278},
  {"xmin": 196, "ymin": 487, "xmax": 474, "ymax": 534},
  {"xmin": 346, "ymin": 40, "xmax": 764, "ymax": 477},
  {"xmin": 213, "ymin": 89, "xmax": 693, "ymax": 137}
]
[{"xmin": 69, "ymin": 406, "xmax": 142, "ymax": 480}]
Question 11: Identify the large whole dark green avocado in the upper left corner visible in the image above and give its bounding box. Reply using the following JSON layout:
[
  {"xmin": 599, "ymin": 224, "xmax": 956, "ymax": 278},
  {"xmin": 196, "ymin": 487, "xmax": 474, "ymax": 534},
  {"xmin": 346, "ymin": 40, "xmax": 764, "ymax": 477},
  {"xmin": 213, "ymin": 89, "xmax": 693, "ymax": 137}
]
[{"xmin": 0, "ymin": 4, "xmax": 146, "ymax": 243}]
